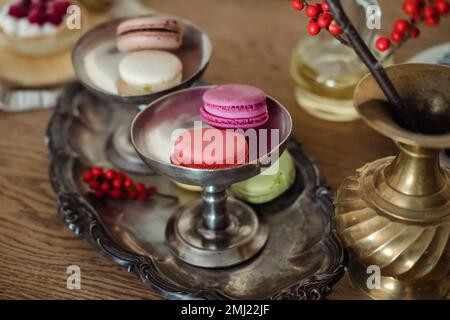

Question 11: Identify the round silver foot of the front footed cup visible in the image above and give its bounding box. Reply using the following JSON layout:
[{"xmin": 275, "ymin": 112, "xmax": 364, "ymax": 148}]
[{"xmin": 166, "ymin": 199, "xmax": 268, "ymax": 268}]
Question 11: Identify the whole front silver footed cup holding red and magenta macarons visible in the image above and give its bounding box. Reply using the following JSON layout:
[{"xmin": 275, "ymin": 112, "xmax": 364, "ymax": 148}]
[{"xmin": 131, "ymin": 87, "xmax": 292, "ymax": 268}]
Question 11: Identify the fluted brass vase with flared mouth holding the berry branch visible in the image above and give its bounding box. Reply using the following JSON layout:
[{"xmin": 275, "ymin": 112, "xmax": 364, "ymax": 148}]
[{"xmin": 336, "ymin": 64, "xmax": 450, "ymax": 299}]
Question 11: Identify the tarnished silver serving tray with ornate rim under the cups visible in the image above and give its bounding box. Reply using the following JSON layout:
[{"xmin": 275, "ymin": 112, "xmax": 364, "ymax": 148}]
[{"xmin": 47, "ymin": 83, "xmax": 346, "ymax": 299}]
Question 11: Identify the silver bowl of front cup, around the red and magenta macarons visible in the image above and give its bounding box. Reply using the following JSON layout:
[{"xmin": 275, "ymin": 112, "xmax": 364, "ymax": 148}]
[{"xmin": 131, "ymin": 86, "xmax": 292, "ymax": 186}]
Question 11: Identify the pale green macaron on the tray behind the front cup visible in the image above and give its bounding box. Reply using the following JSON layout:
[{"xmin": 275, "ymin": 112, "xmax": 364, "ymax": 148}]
[{"xmin": 230, "ymin": 151, "xmax": 296, "ymax": 204}]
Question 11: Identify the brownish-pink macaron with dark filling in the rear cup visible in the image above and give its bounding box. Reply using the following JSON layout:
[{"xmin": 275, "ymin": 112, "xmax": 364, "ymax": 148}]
[{"xmin": 117, "ymin": 16, "xmax": 183, "ymax": 52}]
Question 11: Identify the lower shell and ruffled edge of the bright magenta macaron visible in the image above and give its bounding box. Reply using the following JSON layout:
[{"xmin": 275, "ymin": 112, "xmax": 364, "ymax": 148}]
[{"xmin": 200, "ymin": 107, "xmax": 269, "ymax": 129}]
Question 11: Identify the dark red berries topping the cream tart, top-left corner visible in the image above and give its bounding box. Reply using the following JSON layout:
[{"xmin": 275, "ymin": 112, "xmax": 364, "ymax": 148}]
[{"xmin": 9, "ymin": 0, "xmax": 70, "ymax": 25}]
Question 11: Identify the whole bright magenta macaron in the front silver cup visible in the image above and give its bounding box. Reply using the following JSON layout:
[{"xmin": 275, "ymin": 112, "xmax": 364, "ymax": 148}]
[{"xmin": 200, "ymin": 84, "xmax": 269, "ymax": 129}]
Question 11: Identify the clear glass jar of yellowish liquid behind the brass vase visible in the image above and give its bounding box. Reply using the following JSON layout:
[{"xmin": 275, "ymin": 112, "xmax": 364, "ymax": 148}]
[{"xmin": 290, "ymin": 0, "xmax": 388, "ymax": 121}]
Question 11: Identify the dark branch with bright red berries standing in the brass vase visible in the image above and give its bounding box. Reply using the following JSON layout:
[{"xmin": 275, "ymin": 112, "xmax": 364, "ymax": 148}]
[{"xmin": 291, "ymin": 0, "xmax": 450, "ymax": 131}]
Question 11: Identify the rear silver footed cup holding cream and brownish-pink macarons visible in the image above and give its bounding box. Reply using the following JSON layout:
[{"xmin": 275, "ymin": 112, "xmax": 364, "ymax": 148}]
[{"xmin": 72, "ymin": 18, "xmax": 212, "ymax": 173}]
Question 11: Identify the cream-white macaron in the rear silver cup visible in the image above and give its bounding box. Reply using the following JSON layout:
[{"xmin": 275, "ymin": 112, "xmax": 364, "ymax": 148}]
[{"xmin": 117, "ymin": 50, "xmax": 183, "ymax": 95}]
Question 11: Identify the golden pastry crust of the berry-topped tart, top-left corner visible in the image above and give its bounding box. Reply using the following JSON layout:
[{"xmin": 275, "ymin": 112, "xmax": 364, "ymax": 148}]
[{"xmin": 0, "ymin": 0, "xmax": 85, "ymax": 58}]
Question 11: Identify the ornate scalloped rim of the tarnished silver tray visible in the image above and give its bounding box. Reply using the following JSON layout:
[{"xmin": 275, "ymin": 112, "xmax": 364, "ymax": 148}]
[{"xmin": 46, "ymin": 83, "xmax": 348, "ymax": 300}]
